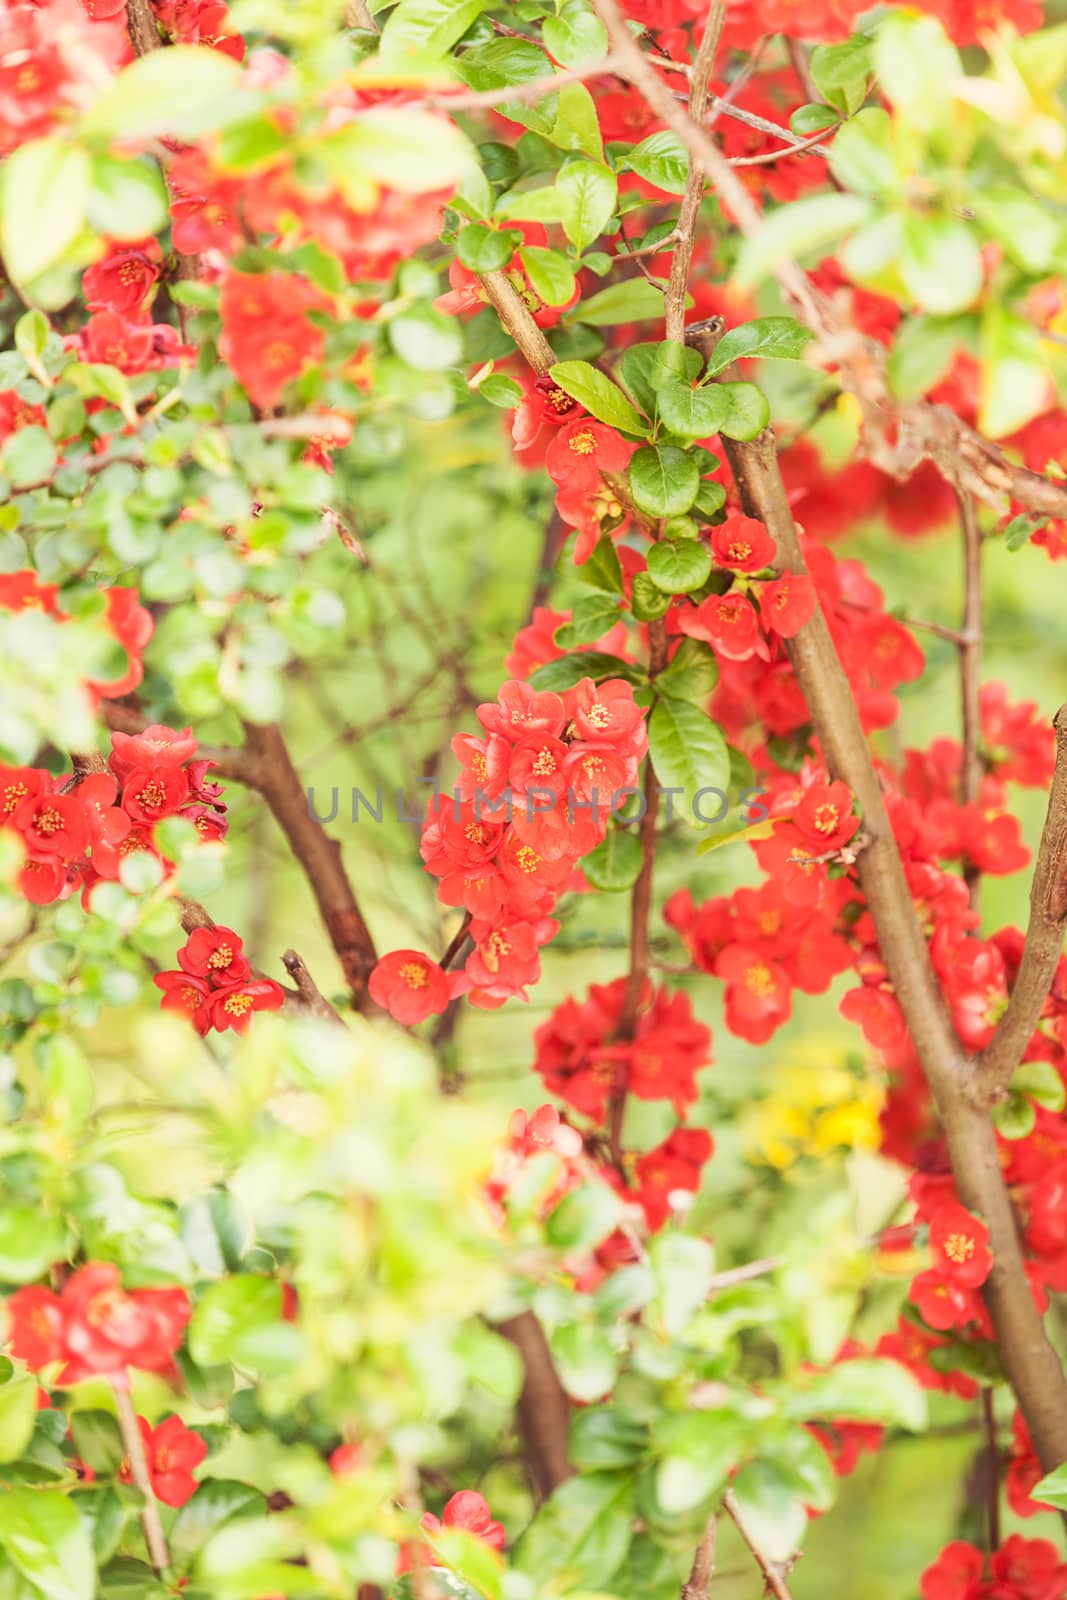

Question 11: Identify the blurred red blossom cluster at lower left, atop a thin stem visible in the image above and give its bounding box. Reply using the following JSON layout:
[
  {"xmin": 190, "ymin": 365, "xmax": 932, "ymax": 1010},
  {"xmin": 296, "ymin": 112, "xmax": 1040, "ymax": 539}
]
[{"xmin": 6, "ymin": 1261, "xmax": 190, "ymax": 1389}]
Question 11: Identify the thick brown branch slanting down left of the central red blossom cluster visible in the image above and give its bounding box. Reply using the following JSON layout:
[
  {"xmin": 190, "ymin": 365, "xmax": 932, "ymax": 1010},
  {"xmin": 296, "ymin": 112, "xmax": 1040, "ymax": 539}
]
[{"xmin": 242, "ymin": 723, "xmax": 378, "ymax": 1011}]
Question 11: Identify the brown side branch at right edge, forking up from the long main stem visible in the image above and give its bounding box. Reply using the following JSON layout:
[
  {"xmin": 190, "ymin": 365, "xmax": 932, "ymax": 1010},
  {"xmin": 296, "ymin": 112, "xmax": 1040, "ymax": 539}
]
[{"xmin": 974, "ymin": 706, "xmax": 1067, "ymax": 1100}]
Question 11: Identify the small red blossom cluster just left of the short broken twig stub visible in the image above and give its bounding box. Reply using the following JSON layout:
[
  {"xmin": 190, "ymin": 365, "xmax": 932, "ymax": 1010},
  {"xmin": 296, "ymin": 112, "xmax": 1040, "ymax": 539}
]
[{"xmin": 152, "ymin": 923, "xmax": 285, "ymax": 1035}]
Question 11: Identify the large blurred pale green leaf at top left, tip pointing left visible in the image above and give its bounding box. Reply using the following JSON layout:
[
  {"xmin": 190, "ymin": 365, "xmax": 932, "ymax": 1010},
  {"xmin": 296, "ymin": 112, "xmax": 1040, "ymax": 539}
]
[{"xmin": 82, "ymin": 45, "xmax": 242, "ymax": 142}]
